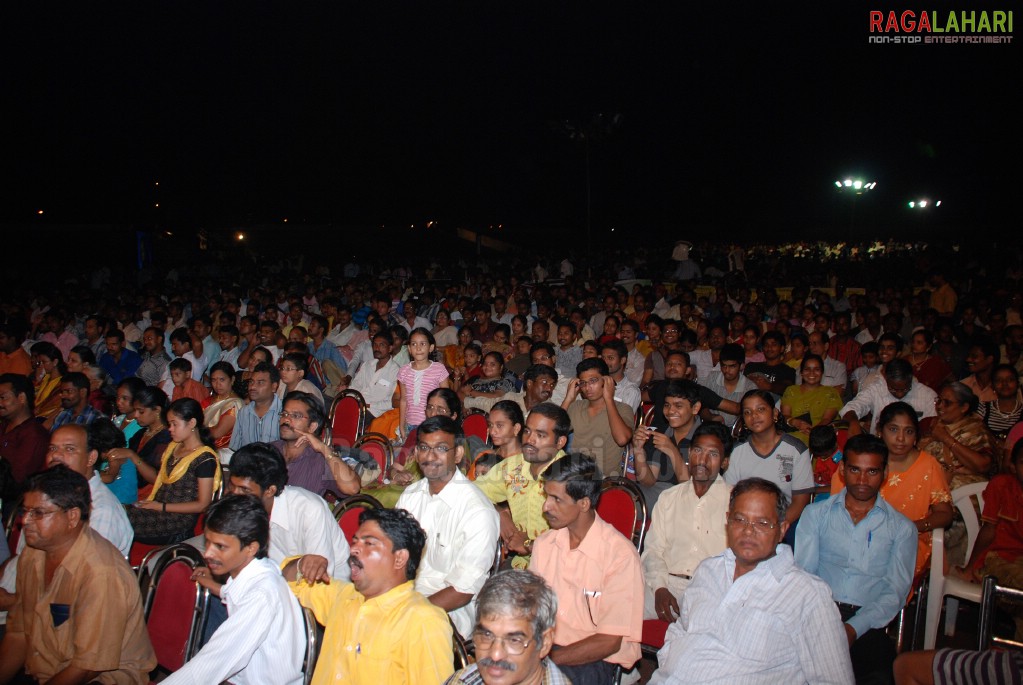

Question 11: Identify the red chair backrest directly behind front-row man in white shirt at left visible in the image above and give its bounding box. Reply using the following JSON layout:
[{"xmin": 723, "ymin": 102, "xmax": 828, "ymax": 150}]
[{"xmin": 142, "ymin": 544, "xmax": 210, "ymax": 672}]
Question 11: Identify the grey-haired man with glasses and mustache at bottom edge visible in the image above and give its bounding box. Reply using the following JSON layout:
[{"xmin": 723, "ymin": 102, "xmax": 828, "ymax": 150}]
[{"xmin": 445, "ymin": 568, "xmax": 569, "ymax": 685}]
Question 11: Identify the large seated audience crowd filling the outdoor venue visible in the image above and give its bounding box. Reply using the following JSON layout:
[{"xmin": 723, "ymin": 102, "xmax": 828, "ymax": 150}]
[{"xmin": 0, "ymin": 237, "xmax": 1023, "ymax": 685}]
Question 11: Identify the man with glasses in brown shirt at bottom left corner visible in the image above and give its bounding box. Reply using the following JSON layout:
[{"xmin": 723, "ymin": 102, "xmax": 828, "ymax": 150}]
[{"xmin": 0, "ymin": 464, "xmax": 157, "ymax": 684}]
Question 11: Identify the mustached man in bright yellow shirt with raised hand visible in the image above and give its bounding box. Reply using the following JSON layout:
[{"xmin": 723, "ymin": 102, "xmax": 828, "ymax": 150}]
[{"xmin": 283, "ymin": 509, "xmax": 454, "ymax": 685}]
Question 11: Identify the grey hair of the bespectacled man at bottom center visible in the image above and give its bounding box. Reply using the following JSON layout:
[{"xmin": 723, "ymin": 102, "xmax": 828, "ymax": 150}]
[{"xmin": 476, "ymin": 568, "xmax": 558, "ymax": 641}]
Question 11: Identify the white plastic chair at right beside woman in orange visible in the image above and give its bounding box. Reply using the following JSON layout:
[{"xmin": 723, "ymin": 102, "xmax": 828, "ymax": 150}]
[{"xmin": 924, "ymin": 481, "xmax": 987, "ymax": 649}]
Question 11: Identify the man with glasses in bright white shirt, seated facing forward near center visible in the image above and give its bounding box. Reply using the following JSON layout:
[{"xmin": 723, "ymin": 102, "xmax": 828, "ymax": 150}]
[{"xmin": 396, "ymin": 416, "xmax": 498, "ymax": 636}]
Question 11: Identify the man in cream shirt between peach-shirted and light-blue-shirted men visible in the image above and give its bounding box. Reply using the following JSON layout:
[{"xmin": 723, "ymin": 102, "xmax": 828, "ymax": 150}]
[{"xmin": 642, "ymin": 422, "xmax": 732, "ymax": 623}]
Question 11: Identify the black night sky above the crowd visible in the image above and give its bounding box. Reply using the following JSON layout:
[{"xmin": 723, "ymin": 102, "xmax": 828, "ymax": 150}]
[{"xmin": 0, "ymin": 1, "xmax": 1023, "ymax": 244}]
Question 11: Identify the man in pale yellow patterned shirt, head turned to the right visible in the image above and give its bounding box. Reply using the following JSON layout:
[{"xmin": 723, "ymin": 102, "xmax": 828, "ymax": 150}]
[{"xmin": 476, "ymin": 402, "xmax": 572, "ymax": 568}]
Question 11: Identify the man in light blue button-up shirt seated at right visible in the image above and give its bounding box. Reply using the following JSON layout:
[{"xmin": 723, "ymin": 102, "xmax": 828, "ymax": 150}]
[{"xmin": 796, "ymin": 435, "xmax": 917, "ymax": 683}]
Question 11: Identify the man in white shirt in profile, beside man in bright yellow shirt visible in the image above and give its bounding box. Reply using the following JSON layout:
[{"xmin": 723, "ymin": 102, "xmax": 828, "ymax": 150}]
[{"xmin": 164, "ymin": 495, "xmax": 306, "ymax": 685}]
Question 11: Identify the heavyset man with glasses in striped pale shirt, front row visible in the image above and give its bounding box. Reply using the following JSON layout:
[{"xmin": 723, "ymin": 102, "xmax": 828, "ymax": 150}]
[{"xmin": 650, "ymin": 478, "xmax": 853, "ymax": 685}]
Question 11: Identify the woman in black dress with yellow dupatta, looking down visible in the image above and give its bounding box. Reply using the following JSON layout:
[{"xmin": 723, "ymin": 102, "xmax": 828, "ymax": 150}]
[{"xmin": 128, "ymin": 398, "xmax": 222, "ymax": 545}]
